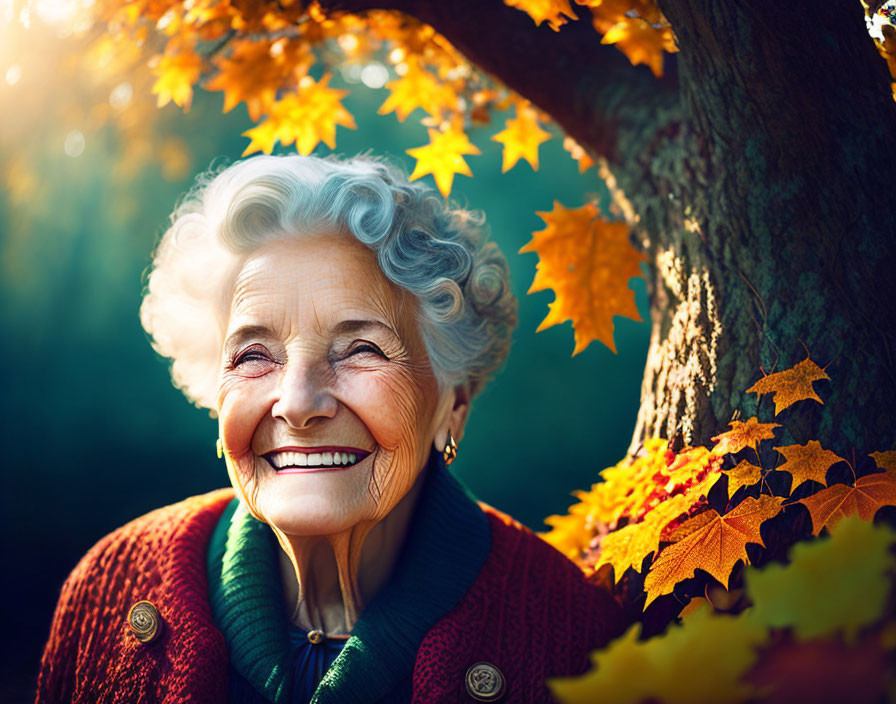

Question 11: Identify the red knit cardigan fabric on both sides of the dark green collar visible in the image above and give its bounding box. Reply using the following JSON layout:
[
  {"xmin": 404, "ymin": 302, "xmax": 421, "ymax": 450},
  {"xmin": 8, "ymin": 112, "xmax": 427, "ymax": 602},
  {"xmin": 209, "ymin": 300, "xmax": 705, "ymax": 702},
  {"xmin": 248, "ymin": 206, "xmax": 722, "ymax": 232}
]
[{"xmin": 36, "ymin": 489, "xmax": 624, "ymax": 704}]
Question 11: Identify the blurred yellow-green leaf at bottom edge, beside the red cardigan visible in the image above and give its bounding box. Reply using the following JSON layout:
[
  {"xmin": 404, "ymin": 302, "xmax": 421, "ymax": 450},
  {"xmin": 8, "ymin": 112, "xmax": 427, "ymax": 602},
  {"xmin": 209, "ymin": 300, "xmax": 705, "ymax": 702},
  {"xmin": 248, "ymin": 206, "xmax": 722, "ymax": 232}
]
[{"xmin": 547, "ymin": 608, "xmax": 768, "ymax": 704}]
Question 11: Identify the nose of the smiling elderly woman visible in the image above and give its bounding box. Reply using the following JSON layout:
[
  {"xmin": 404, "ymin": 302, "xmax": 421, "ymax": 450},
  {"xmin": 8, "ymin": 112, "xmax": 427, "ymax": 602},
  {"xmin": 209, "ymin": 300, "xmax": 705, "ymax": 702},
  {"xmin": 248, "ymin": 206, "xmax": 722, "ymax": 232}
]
[{"xmin": 271, "ymin": 362, "xmax": 339, "ymax": 429}]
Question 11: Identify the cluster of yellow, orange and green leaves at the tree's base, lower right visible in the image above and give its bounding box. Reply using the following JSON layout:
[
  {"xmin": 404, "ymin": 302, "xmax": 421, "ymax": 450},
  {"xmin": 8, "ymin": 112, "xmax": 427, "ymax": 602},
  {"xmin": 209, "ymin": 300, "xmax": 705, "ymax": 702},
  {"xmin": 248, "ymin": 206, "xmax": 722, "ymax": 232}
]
[{"xmin": 544, "ymin": 357, "xmax": 896, "ymax": 704}]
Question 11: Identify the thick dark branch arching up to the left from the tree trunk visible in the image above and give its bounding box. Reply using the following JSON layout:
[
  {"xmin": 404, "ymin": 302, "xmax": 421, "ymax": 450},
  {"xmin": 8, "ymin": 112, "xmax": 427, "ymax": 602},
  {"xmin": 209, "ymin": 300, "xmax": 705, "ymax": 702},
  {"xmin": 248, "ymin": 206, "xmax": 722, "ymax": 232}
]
[{"xmin": 321, "ymin": 0, "xmax": 678, "ymax": 184}]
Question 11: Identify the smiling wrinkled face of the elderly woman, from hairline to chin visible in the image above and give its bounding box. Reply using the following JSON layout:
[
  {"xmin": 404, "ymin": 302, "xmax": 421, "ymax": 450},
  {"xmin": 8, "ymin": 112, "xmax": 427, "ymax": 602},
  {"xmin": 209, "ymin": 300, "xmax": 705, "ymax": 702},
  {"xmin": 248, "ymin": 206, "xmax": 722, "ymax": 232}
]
[{"xmin": 217, "ymin": 233, "xmax": 447, "ymax": 535}]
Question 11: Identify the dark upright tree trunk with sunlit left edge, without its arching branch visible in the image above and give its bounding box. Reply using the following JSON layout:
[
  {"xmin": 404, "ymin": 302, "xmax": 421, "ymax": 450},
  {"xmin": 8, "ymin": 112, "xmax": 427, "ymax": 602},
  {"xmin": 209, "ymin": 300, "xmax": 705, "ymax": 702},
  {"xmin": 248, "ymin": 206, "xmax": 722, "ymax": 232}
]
[{"xmin": 621, "ymin": 0, "xmax": 896, "ymax": 459}]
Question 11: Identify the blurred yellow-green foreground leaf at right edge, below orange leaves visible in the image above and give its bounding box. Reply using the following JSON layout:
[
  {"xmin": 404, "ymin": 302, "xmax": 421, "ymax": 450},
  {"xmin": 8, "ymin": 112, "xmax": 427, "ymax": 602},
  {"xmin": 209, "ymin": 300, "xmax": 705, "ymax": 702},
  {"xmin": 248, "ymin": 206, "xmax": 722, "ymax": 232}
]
[{"xmin": 745, "ymin": 517, "xmax": 896, "ymax": 640}]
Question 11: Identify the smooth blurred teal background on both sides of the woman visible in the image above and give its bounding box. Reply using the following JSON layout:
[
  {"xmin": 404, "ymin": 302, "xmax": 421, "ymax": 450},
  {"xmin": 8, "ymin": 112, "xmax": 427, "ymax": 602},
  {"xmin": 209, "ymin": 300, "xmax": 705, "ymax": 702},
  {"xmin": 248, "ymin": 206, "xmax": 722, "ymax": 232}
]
[{"xmin": 0, "ymin": 40, "xmax": 649, "ymax": 702}]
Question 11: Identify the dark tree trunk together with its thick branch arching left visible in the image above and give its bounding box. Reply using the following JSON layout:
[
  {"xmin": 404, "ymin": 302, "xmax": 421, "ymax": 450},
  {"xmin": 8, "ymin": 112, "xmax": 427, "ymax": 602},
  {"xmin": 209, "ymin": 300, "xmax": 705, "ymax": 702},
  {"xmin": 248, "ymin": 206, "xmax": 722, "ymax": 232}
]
[{"xmin": 325, "ymin": 0, "xmax": 896, "ymax": 459}]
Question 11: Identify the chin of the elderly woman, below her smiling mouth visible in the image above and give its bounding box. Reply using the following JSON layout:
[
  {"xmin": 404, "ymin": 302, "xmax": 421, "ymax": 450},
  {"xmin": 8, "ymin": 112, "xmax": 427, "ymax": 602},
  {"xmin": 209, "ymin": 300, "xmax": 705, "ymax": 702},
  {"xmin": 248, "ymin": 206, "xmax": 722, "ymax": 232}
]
[{"xmin": 255, "ymin": 470, "xmax": 376, "ymax": 535}]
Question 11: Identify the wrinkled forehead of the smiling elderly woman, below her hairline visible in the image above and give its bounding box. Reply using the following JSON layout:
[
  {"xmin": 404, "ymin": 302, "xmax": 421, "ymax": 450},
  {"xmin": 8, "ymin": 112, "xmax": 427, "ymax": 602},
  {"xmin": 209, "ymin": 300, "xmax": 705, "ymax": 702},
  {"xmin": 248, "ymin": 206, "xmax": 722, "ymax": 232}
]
[{"xmin": 228, "ymin": 228, "xmax": 414, "ymax": 330}]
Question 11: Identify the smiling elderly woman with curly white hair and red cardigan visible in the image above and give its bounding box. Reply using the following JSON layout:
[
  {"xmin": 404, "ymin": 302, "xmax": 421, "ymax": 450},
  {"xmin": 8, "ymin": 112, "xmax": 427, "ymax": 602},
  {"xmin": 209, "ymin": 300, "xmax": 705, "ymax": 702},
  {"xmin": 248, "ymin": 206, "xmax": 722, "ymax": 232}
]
[{"xmin": 37, "ymin": 156, "xmax": 622, "ymax": 703}]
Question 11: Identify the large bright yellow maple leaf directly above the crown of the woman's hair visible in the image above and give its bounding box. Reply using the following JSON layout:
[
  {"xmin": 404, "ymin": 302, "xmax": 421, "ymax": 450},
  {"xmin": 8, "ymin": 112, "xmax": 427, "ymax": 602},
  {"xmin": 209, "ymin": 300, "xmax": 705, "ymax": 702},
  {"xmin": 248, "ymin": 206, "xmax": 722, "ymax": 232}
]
[{"xmin": 243, "ymin": 74, "xmax": 355, "ymax": 156}]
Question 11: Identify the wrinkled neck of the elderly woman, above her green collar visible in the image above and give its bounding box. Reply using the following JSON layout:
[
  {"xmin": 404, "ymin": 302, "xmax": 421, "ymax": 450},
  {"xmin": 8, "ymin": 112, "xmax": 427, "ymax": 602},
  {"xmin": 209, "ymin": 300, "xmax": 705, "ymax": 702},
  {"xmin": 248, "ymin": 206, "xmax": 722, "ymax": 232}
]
[{"xmin": 274, "ymin": 467, "xmax": 427, "ymax": 636}]
